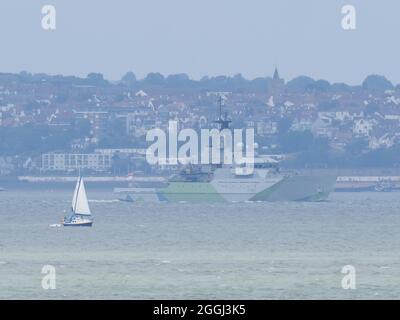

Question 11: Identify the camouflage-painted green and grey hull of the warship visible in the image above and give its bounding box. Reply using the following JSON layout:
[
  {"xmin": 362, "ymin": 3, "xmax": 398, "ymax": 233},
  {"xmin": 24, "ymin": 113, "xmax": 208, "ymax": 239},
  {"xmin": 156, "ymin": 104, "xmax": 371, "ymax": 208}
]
[{"xmin": 115, "ymin": 175, "xmax": 337, "ymax": 203}]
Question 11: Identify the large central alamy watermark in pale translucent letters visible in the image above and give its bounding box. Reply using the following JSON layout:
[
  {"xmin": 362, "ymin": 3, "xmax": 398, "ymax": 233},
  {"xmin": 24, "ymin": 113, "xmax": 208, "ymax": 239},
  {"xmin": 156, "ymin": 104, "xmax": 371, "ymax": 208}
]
[{"xmin": 146, "ymin": 121, "xmax": 255, "ymax": 173}]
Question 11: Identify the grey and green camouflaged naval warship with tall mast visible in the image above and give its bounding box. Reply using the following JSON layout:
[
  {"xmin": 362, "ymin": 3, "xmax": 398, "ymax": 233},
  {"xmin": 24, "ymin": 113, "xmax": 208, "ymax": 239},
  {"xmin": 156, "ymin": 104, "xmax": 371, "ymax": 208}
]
[{"xmin": 114, "ymin": 100, "xmax": 337, "ymax": 203}]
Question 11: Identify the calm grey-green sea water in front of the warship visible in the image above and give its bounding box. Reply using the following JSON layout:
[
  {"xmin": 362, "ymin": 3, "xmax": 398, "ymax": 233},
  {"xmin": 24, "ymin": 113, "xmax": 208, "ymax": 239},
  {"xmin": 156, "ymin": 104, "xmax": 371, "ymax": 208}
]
[{"xmin": 0, "ymin": 190, "xmax": 400, "ymax": 299}]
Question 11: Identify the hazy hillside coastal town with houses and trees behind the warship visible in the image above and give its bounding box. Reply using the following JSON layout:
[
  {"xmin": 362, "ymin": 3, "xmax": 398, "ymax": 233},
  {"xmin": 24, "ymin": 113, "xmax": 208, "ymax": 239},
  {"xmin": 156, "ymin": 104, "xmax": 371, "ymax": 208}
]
[{"xmin": 0, "ymin": 68, "xmax": 400, "ymax": 176}]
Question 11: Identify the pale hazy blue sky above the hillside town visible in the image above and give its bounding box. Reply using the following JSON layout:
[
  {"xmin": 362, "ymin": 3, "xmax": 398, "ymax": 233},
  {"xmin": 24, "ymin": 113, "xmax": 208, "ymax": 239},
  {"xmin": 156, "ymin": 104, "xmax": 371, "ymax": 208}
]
[{"xmin": 0, "ymin": 0, "xmax": 400, "ymax": 84}]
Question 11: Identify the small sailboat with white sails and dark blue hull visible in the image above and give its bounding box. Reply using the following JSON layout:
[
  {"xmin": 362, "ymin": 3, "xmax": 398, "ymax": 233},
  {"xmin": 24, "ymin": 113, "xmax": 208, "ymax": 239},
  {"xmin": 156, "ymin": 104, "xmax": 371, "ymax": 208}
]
[{"xmin": 63, "ymin": 176, "xmax": 93, "ymax": 227}]
